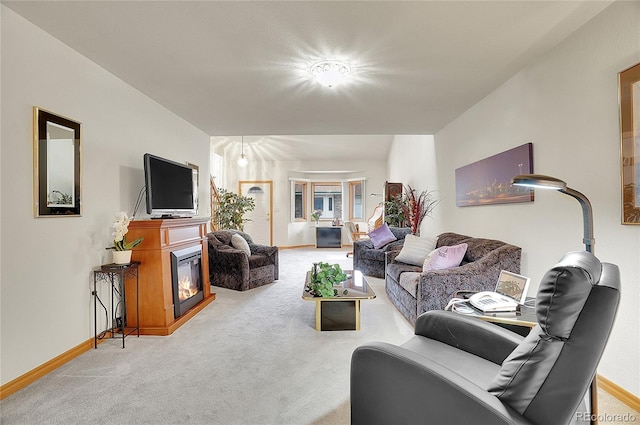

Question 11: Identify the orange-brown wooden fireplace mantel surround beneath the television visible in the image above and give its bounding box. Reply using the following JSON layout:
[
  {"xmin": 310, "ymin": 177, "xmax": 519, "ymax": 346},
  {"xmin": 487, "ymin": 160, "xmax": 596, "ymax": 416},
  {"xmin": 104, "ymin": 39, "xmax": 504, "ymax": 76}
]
[{"xmin": 126, "ymin": 217, "xmax": 216, "ymax": 335}]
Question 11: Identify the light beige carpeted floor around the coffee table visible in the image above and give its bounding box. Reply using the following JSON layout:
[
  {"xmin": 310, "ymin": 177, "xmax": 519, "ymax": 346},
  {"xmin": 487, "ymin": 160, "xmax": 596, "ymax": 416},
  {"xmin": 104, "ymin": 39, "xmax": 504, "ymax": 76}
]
[{"xmin": 0, "ymin": 248, "xmax": 413, "ymax": 425}]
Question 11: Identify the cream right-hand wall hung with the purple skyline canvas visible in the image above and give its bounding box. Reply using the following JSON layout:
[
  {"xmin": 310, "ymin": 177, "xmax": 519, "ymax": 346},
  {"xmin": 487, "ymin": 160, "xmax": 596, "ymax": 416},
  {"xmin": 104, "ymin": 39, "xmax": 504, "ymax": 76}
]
[{"xmin": 390, "ymin": 2, "xmax": 640, "ymax": 396}]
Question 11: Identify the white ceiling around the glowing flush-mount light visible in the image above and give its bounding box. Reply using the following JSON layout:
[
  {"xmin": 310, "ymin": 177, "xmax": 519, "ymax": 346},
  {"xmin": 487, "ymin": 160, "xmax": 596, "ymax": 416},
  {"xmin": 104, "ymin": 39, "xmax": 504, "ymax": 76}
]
[{"xmin": 2, "ymin": 0, "xmax": 611, "ymax": 161}]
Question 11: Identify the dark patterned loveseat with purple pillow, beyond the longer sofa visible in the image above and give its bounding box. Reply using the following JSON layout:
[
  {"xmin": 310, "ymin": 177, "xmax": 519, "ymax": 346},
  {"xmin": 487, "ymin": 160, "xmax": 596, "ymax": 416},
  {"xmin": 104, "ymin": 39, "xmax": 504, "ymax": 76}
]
[{"xmin": 353, "ymin": 226, "xmax": 411, "ymax": 279}]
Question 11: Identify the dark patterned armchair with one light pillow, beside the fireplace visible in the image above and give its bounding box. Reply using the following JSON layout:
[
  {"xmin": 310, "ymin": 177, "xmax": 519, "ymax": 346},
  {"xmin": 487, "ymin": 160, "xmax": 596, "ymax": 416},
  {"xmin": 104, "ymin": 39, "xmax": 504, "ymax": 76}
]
[{"xmin": 207, "ymin": 230, "xmax": 278, "ymax": 291}]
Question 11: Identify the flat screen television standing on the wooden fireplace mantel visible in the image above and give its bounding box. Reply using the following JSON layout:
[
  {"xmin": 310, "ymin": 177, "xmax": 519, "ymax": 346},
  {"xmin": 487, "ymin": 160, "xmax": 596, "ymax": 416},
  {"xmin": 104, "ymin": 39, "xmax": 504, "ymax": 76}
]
[{"xmin": 144, "ymin": 153, "xmax": 198, "ymax": 218}]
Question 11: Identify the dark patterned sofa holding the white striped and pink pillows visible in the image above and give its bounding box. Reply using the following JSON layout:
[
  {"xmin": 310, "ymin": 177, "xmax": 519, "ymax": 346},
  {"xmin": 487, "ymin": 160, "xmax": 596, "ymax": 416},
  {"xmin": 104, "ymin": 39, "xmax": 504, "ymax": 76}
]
[{"xmin": 385, "ymin": 233, "xmax": 522, "ymax": 324}]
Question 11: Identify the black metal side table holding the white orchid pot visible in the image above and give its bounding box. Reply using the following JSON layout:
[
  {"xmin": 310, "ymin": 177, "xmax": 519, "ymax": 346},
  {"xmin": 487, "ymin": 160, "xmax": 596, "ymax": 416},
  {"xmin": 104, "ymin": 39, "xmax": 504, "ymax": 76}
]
[{"xmin": 92, "ymin": 261, "xmax": 140, "ymax": 348}]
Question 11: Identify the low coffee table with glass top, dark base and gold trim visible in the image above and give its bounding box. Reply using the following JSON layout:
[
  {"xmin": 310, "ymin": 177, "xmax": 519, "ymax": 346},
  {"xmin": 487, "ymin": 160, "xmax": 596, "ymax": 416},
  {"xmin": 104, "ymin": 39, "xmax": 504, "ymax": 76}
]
[{"xmin": 302, "ymin": 270, "xmax": 376, "ymax": 331}]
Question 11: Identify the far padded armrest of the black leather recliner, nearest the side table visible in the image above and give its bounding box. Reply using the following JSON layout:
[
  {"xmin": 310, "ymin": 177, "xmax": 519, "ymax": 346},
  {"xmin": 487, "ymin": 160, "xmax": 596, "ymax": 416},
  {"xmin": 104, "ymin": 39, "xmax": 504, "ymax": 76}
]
[{"xmin": 415, "ymin": 310, "xmax": 524, "ymax": 364}]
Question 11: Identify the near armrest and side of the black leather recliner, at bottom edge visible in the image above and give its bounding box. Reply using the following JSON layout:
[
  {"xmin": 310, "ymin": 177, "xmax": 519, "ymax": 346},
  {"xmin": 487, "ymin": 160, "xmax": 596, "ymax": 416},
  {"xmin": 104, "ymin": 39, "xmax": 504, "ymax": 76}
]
[{"xmin": 351, "ymin": 342, "xmax": 530, "ymax": 425}]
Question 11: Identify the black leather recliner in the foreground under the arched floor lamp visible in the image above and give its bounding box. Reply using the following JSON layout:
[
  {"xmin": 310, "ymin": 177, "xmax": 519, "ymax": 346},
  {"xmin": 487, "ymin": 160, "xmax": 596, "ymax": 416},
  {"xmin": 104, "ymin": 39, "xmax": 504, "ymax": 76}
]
[{"xmin": 351, "ymin": 252, "xmax": 620, "ymax": 425}]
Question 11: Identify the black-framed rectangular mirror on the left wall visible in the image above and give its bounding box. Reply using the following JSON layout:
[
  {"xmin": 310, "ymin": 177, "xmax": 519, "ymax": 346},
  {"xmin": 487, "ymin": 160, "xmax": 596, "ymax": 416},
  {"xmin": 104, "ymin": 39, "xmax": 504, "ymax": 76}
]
[{"xmin": 33, "ymin": 106, "xmax": 81, "ymax": 217}]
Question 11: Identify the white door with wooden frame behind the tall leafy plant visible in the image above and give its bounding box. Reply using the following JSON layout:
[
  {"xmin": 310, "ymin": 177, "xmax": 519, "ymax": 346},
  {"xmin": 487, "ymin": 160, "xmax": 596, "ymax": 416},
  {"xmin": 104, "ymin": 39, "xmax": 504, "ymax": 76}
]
[{"xmin": 238, "ymin": 180, "xmax": 273, "ymax": 245}]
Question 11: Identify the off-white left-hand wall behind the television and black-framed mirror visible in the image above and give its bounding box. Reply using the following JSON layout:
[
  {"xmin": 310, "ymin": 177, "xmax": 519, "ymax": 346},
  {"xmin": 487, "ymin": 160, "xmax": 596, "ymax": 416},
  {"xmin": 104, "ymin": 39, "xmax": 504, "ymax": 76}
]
[{"xmin": 0, "ymin": 6, "xmax": 209, "ymax": 384}]
